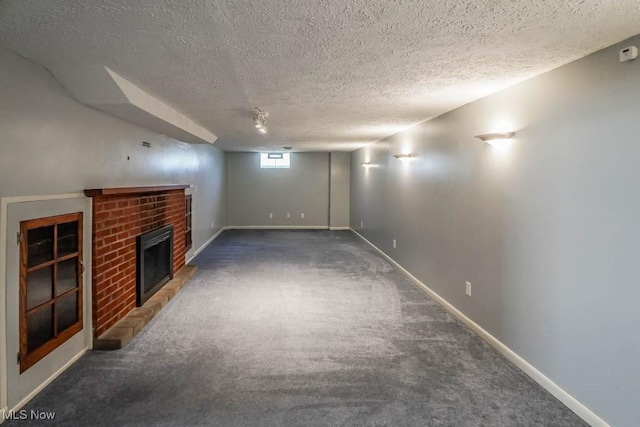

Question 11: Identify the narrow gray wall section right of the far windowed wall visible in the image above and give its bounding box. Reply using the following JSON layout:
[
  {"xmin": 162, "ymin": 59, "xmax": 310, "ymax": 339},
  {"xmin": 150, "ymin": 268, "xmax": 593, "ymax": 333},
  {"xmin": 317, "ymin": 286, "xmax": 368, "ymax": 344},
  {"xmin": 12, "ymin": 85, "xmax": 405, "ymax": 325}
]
[{"xmin": 329, "ymin": 152, "xmax": 351, "ymax": 228}]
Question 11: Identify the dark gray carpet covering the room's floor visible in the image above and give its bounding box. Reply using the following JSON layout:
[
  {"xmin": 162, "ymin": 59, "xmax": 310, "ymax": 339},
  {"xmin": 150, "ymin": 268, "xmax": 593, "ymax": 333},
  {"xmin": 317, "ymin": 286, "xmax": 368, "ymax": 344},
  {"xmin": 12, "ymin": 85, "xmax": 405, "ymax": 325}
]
[{"xmin": 7, "ymin": 231, "xmax": 585, "ymax": 426}]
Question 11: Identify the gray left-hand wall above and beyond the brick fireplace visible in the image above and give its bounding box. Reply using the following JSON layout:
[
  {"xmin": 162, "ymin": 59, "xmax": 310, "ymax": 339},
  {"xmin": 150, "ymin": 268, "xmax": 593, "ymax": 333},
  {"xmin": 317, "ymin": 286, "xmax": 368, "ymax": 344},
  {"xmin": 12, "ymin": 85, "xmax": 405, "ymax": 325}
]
[{"xmin": 0, "ymin": 49, "xmax": 226, "ymax": 254}]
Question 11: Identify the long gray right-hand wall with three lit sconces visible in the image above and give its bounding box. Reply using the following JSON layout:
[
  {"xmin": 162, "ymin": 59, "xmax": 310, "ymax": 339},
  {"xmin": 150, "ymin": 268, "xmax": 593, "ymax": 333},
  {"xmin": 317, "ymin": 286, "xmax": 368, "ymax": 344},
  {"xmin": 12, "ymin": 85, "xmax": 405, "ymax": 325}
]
[{"xmin": 351, "ymin": 37, "xmax": 640, "ymax": 426}]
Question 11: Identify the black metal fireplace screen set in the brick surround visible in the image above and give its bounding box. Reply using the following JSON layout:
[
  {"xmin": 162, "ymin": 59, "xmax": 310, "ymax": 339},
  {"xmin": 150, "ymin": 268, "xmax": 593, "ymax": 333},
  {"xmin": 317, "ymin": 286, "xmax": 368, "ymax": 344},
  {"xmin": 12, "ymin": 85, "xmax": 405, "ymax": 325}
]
[{"xmin": 136, "ymin": 225, "xmax": 173, "ymax": 307}]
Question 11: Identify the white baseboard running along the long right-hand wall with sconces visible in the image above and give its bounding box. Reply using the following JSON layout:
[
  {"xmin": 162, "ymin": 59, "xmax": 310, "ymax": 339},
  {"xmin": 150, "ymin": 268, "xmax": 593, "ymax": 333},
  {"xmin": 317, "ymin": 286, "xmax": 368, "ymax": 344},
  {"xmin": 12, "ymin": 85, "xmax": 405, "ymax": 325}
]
[{"xmin": 351, "ymin": 229, "xmax": 610, "ymax": 427}]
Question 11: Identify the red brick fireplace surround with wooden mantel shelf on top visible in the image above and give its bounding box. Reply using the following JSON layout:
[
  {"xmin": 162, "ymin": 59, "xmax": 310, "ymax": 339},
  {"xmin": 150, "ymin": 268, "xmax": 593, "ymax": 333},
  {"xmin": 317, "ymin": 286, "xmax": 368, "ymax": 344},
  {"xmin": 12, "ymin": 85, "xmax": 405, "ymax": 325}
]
[{"xmin": 85, "ymin": 185, "xmax": 188, "ymax": 338}]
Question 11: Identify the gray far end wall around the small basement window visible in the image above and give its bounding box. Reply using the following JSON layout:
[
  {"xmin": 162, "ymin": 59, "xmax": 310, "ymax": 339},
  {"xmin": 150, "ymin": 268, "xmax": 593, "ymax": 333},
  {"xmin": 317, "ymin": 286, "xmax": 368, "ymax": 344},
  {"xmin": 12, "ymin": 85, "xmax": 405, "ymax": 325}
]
[{"xmin": 226, "ymin": 152, "xmax": 329, "ymax": 227}]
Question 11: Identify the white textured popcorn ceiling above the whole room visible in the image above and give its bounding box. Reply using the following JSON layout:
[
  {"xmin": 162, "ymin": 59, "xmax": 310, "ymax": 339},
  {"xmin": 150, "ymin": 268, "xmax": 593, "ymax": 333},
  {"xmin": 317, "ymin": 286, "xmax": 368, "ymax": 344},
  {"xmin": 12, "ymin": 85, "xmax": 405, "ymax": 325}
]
[{"xmin": 0, "ymin": 0, "xmax": 640, "ymax": 151}]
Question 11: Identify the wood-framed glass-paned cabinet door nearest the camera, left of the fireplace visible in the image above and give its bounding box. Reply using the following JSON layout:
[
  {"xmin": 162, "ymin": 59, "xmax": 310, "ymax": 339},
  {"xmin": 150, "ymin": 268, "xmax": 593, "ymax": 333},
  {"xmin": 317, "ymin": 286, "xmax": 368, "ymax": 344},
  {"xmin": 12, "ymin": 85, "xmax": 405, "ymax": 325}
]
[{"xmin": 18, "ymin": 212, "xmax": 84, "ymax": 373}]
